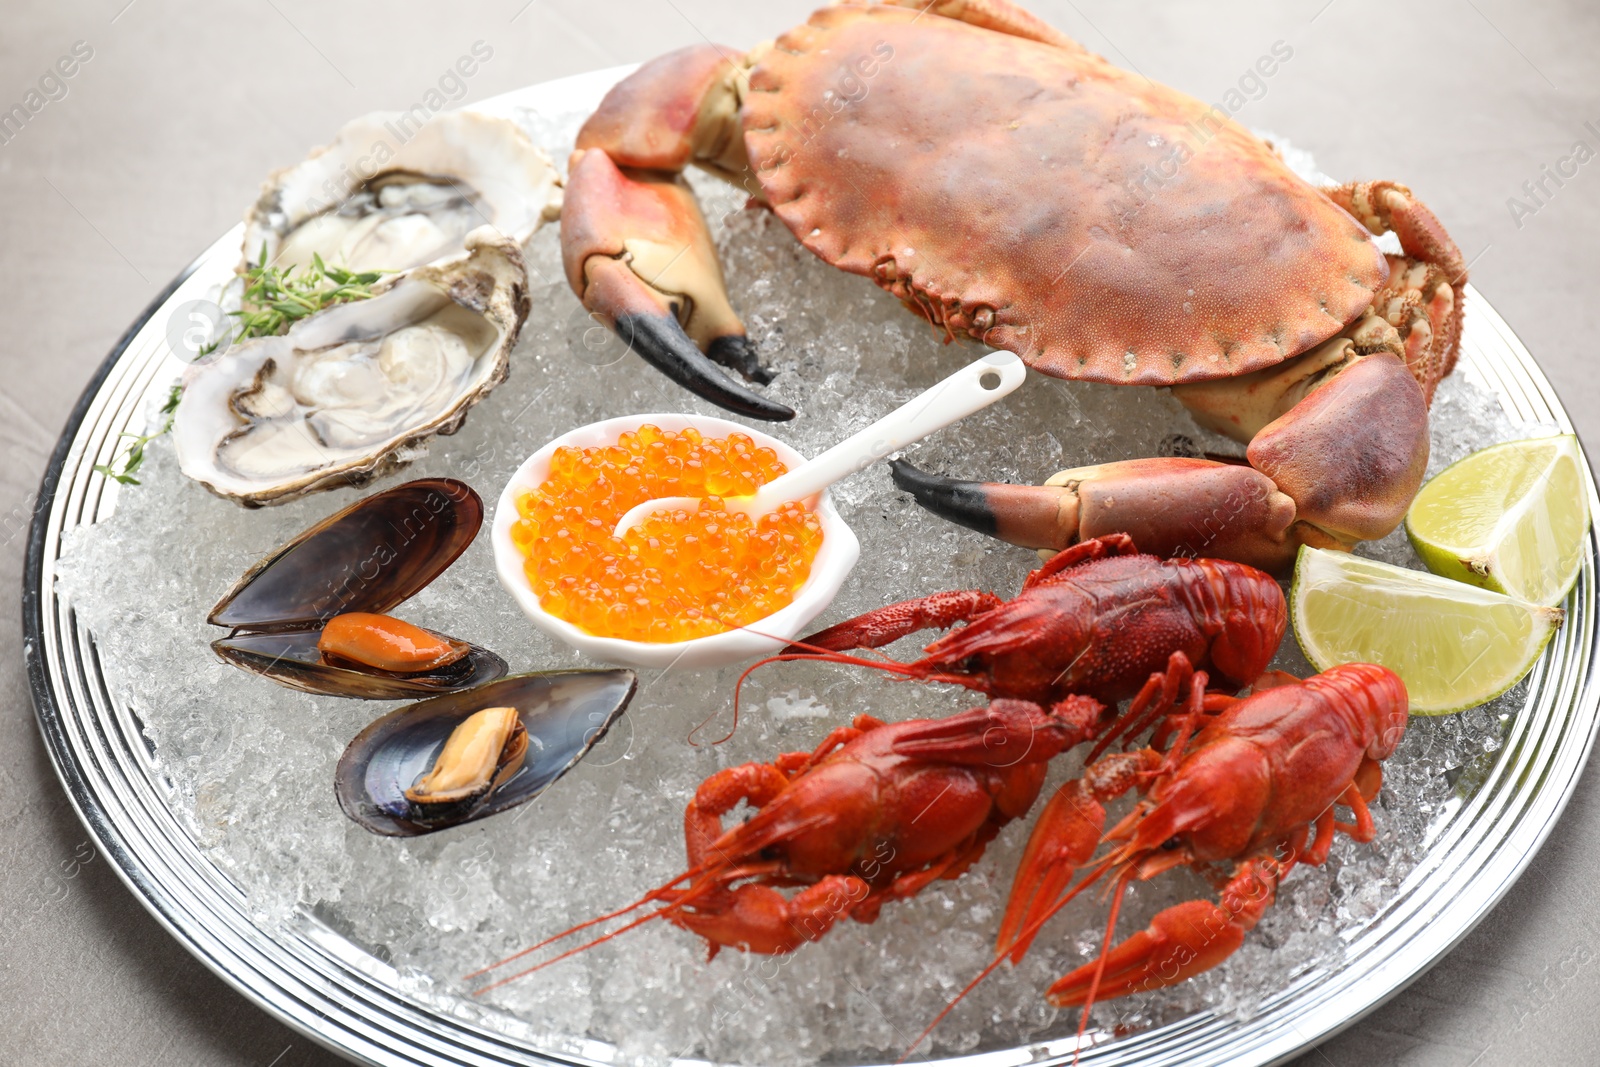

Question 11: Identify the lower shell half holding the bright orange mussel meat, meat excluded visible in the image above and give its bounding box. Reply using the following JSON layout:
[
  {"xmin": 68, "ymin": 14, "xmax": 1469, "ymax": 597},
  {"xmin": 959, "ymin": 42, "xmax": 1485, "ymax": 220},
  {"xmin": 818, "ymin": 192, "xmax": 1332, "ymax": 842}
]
[{"xmin": 211, "ymin": 630, "xmax": 506, "ymax": 701}]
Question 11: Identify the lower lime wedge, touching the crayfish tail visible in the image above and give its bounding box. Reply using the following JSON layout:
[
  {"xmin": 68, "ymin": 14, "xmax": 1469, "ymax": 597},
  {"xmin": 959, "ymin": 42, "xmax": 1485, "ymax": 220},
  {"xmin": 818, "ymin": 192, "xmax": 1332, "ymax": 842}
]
[{"xmin": 1290, "ymin": 549, "xmax": 1563, "ymax": 715}]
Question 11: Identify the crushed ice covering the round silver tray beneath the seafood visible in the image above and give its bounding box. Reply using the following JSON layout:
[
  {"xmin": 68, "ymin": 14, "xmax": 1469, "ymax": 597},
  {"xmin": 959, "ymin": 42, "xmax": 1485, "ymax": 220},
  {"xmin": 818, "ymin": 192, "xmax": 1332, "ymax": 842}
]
[{"xmin": 59, "ymin": 112, "xmax": 1561, "ymax": 1064}]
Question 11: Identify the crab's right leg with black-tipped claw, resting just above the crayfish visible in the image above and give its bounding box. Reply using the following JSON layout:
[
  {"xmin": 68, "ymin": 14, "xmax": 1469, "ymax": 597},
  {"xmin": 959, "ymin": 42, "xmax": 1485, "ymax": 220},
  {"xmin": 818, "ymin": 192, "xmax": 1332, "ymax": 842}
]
[{"xmin": 894, "ymin": 339, "xmax": 1429, "ymax": 574}]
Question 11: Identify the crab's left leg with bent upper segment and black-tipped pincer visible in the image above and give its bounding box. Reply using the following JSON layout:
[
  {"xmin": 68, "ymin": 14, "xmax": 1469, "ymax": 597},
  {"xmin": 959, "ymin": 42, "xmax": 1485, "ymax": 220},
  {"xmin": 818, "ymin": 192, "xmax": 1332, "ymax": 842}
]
[{"xmin": 562, "ymin": 45, "xmax": 794, "ymax": 421}]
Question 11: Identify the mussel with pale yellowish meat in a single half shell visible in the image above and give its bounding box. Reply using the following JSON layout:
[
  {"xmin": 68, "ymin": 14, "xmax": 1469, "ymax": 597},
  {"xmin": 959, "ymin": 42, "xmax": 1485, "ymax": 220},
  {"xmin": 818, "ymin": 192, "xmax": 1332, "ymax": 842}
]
[{"xmin": 334, "ymin": 670, "xmax": 637, "ymax": 837}]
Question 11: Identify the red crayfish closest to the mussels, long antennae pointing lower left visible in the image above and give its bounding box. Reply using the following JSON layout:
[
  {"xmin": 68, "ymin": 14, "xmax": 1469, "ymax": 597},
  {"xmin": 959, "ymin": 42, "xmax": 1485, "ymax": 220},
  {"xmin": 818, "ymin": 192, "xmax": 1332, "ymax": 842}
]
[{"xmin": 467, "ymin": 696, "xmax": 1106, "ymax": 992}]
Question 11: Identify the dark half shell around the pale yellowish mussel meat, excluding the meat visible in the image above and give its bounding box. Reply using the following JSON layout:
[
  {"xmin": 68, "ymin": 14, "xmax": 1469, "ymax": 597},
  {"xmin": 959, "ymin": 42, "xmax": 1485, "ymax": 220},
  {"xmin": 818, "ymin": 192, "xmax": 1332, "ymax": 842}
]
[{"xmin": 334, "ymin": 670, "xmax": 638, "ymax": 837}]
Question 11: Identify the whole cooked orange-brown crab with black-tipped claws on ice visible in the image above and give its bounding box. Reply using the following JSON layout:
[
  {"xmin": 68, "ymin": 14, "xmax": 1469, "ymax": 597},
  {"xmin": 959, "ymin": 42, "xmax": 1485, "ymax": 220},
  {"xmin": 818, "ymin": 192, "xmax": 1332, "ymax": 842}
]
[{"xmin": 562, "ymin": 0, "xmax": 1466, "ymax": 571}]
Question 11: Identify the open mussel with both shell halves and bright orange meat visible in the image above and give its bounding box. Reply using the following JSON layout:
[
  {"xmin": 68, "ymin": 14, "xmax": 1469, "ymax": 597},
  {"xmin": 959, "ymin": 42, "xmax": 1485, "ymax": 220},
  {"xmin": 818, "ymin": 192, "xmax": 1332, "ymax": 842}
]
[{"xmin": 208, "ymin": 478, "xmax": 506, "ymax": 699}]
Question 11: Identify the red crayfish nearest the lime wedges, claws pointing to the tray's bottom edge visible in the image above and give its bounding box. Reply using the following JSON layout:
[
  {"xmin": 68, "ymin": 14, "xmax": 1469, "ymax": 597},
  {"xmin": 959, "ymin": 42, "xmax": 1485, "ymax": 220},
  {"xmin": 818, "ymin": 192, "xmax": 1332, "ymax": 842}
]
[{"xmin": 925, "ymin": 664, "xmax": 1408, "ymax": 1041}]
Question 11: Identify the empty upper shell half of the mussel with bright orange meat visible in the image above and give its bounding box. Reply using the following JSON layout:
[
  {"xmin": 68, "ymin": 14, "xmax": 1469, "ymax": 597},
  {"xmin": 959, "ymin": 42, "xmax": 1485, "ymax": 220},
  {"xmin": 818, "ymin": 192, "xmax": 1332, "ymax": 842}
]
[{"xmin": 206, "ymin": 478, "xmax": 483, "ymax": 630}]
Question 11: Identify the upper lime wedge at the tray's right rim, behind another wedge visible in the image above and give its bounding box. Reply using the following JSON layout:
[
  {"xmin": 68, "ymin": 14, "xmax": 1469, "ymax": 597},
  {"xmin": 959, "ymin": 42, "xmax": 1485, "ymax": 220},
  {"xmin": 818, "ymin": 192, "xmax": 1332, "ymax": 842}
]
[{"xmin": 1405, "ymin": 434, "xmax": 1589, "ymax": 605}]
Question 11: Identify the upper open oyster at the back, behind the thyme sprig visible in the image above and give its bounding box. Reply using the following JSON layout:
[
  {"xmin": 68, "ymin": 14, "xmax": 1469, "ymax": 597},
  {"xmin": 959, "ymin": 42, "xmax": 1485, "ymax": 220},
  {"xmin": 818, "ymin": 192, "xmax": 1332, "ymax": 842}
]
[{"xmin": 243, "ymin": 110, "xmax": 562, "ymax": 272}]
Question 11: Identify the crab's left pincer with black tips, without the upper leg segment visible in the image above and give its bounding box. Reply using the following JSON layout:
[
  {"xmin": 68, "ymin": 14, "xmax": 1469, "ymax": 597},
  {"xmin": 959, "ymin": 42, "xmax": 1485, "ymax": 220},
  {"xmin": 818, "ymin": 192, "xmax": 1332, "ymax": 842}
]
[{"xmin": 562, "ymin": 149, "xmax": 795, "ymax": 422}]
